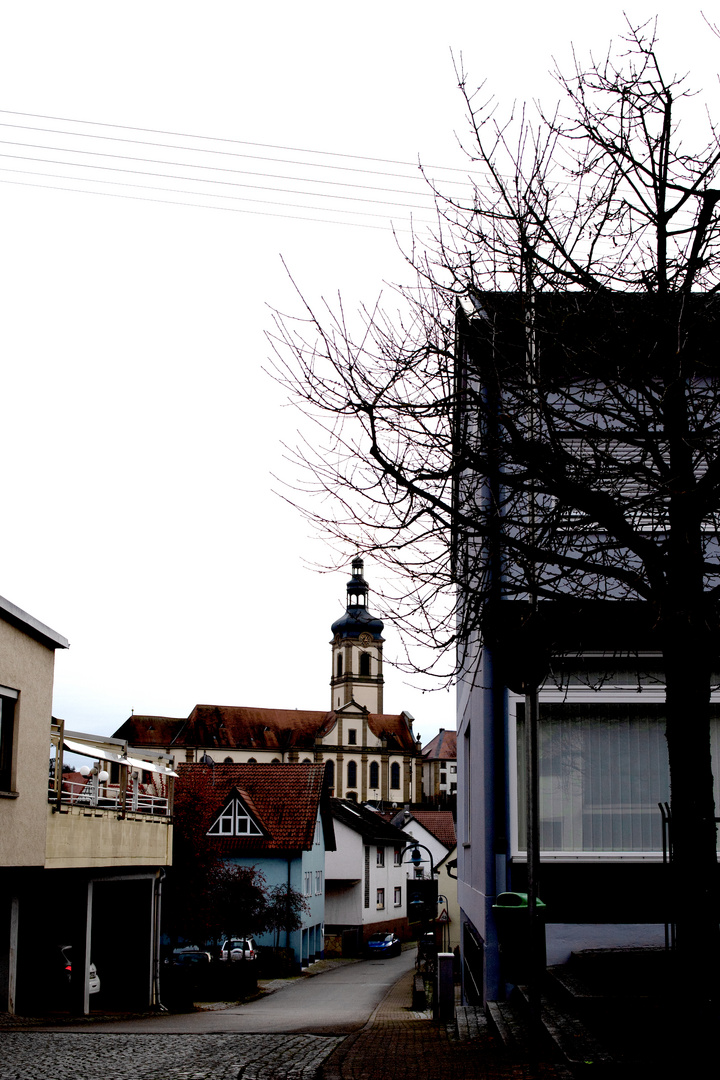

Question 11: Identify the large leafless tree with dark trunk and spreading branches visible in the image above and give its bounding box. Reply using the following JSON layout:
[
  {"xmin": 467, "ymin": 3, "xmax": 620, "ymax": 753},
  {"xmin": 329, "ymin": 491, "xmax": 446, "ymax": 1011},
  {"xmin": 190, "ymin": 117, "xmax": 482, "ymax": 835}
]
[{"xmin": 268, "ymin": 26, "xmax": 720, "ymax": 1000}]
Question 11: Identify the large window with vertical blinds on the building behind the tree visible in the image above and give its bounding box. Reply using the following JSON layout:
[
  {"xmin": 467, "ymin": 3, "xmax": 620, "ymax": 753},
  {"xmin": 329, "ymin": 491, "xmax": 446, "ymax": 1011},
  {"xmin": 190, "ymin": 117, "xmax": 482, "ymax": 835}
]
[{"xmin": 516, "ymin": 701, "xmax": 720, "ymax": 853}]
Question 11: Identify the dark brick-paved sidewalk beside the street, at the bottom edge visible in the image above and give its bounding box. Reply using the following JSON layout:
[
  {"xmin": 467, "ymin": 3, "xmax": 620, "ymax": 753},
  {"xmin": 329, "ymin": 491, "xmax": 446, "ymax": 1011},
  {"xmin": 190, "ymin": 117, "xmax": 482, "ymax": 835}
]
[{"xmin": 320, "ymin": 971, "xmax": 561, "ymax": 1080}]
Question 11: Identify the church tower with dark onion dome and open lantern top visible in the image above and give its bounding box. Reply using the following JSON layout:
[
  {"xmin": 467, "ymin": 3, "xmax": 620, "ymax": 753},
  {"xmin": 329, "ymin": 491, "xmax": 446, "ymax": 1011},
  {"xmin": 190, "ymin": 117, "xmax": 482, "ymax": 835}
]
[{"xmin": 330, "ymin": 555, "xmax": 383, "ymax": 713}]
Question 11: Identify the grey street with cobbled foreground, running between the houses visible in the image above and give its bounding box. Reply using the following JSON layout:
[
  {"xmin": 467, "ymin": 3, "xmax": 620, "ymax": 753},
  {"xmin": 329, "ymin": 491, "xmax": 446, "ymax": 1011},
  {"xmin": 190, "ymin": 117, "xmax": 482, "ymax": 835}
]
[{"xmin": 0, "ymin": 950, "xmax": 415, "ymax": 1080}]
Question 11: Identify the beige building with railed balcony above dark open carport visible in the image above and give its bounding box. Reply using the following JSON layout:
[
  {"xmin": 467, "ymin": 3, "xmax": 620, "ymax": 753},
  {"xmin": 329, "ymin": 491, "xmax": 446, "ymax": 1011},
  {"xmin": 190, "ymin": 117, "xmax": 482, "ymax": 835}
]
[{"xmin": 0, "ymin": 598, "xmax": 173, "ymax": 1013}]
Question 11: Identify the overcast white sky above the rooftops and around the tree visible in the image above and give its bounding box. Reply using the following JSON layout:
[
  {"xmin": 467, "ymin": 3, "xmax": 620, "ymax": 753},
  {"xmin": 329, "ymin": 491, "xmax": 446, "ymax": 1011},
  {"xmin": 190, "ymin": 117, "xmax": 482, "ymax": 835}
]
[{"xmin": 0, "ymin": 0, "xmax": 720, "ymax": 742}]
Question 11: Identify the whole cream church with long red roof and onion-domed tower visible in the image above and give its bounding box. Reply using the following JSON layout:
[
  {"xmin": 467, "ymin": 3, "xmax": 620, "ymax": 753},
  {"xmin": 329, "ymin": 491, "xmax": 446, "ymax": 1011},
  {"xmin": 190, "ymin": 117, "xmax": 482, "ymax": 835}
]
[{"xmin": 116, "ymin": 556, "xmax": 422, "ymax": 806}]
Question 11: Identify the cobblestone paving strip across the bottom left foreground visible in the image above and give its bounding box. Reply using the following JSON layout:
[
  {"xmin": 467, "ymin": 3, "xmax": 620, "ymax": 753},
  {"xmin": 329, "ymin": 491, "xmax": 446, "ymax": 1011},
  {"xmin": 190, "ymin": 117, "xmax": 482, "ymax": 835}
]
[{"xmin": 0, "ymin": 1031, "xmax": 342, "ymax": 1080}]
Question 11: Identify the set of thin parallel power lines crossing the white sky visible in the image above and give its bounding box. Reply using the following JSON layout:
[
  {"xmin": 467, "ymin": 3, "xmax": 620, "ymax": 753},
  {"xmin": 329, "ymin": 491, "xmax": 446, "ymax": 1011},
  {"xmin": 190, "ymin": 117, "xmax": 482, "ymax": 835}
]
[{"xmin": 0, "ymin": 109, "xmax": 481, "ymax": 231}]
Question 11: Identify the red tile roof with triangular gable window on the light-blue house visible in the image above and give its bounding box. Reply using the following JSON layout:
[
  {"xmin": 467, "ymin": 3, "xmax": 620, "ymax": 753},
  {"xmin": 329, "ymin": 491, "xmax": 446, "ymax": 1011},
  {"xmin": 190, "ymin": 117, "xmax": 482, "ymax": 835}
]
[{"xmin": 176, "ymin": 764, "xmax": 334, "ymax": 855}]
